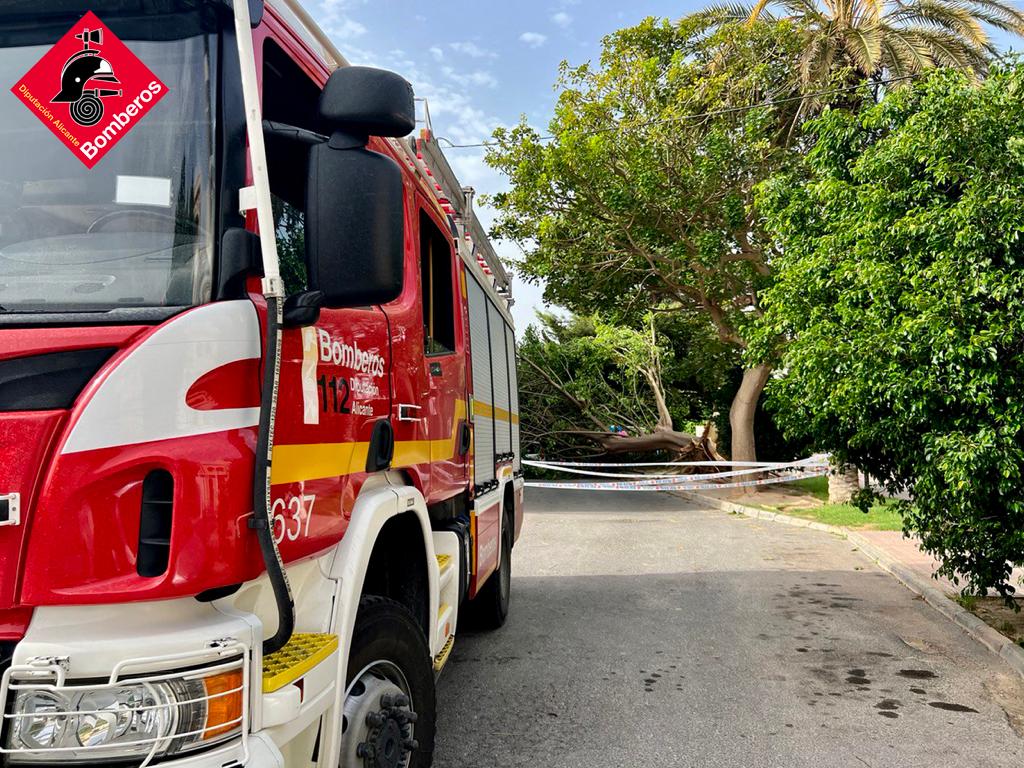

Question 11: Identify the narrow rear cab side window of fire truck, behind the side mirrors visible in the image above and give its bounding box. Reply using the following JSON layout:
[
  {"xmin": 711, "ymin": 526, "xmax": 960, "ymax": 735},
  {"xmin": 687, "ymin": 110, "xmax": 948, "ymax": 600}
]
[{"xmin": 420, "ymin": 211, "xmax": 455, "ymax": 354}]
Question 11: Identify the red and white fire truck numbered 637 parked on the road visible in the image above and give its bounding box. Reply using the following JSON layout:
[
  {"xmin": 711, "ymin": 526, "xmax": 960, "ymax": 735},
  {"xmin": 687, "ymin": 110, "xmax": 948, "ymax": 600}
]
[{"xmin": 0, "ymin": 0, "xmax": 523, "ymax": 768}]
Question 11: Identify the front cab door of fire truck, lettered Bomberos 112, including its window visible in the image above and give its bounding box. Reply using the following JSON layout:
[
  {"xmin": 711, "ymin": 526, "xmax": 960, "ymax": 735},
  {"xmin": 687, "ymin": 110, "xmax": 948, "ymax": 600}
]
[{"xmin": 260, "ymin": 37, "xmax": 391, "ymax": 560}]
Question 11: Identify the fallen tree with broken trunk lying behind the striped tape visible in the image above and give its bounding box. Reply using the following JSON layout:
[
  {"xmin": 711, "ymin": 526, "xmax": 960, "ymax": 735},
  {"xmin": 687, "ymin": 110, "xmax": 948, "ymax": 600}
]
[{"xmin": 519, "ymin": 312, "xmax": 733, "ymax": 461}]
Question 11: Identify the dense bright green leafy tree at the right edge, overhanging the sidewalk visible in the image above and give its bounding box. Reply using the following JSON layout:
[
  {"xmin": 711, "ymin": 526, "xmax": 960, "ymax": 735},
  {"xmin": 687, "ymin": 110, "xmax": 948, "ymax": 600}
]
[{"xmin": 759, "ymin": 65, "xmax": 1024, "ymax": 596}]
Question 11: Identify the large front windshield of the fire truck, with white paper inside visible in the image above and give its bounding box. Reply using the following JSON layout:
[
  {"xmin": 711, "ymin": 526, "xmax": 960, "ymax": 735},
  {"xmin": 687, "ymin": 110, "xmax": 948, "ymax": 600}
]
[{"xmin": 0, "ymin": 34, "xmax": 217, "ymax": 313}]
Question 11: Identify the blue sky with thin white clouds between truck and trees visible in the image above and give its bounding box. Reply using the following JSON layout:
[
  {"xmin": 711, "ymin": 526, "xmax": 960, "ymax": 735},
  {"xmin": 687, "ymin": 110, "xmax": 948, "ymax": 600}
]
[{"xmin": 306, "ymin": 0, "xmax": 1019, "ymax": 332}]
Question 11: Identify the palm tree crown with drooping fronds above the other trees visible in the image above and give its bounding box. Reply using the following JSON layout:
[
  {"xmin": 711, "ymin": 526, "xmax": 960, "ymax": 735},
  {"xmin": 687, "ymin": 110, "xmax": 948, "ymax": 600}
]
[{"xmin": 696, "ymin": 0, "xmax": 1024, "ymax": 90}]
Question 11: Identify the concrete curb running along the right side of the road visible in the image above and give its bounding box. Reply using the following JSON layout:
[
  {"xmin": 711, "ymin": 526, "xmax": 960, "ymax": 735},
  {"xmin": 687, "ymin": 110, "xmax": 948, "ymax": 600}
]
[{"xmin": 676, "ymin": 490, "xmax": 1024, "ymax": 678}]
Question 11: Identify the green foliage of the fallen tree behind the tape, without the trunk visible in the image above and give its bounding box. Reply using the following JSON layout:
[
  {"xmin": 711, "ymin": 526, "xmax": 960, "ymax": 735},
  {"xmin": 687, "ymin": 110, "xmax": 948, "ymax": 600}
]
[{"xmin": 518, "ymin": 313, "xmax": 735, "ymax": 458}]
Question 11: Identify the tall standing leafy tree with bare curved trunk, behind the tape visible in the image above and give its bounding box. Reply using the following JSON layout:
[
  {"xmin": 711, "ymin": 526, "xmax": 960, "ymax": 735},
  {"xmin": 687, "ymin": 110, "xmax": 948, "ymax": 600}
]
[{"xmin": 487, "ymin": 18, "xmax": 801, "ymax": 460}]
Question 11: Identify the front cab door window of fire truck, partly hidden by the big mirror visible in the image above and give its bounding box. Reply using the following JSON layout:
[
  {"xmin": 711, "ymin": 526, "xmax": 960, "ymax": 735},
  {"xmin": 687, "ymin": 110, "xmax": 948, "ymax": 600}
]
[{"xmin": 263, "ymin": 40, "xmax": 321, "ymax": 295}]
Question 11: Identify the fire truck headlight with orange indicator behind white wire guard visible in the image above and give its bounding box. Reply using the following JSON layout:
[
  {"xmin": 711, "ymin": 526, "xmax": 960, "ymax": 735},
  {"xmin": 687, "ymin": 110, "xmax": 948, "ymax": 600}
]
[{"xmin": 4, "ymin": 670, "xmax": 244, "ymax": 764}]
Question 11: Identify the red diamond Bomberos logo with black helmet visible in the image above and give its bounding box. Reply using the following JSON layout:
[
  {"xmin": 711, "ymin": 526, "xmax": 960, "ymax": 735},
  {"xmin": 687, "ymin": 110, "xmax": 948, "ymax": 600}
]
[{"xmin": 11, "ymin": 11, "xmax": 167, "ymax": 168}]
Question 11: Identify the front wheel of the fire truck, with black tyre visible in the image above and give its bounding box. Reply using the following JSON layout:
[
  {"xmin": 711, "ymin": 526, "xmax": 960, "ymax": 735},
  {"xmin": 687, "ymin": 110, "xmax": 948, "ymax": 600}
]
[{"xmin": 339, "ymin": 596, "xmax": 436, "ymax": 768}]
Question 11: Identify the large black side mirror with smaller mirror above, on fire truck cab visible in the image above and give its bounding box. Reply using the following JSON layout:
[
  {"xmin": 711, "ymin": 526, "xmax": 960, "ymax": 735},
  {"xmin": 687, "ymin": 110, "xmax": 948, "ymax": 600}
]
[{"xmin": 305, "ymin": 67, "xmax": 416, "ymax": 308}]
